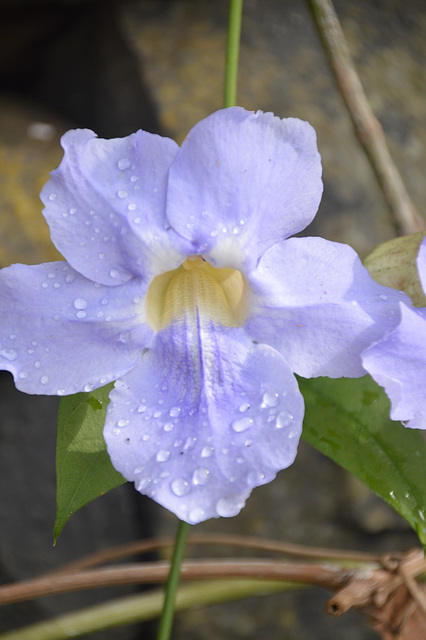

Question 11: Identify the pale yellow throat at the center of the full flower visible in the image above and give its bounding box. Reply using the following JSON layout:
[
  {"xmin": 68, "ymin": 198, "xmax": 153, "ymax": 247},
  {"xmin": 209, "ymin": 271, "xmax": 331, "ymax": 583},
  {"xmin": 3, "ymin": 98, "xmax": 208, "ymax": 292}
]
[{"xmin": 146, "ymin": 256, "xmax": 248, "ymax": 331}]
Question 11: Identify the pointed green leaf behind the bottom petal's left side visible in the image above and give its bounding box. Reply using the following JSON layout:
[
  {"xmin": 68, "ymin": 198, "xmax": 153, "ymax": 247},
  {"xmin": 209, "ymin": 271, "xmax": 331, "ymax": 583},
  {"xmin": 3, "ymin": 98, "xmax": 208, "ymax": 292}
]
[{"xmin": 53, "ymin": 384, "xmax": 126, "ymax": 542}]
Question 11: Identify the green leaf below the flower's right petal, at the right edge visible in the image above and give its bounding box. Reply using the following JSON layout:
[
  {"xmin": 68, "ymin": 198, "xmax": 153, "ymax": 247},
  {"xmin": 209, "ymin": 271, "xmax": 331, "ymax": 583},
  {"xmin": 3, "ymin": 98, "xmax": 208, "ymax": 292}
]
[{"xmin": 299, "ymin": 376, "xmax": 426, "ymax": 546}]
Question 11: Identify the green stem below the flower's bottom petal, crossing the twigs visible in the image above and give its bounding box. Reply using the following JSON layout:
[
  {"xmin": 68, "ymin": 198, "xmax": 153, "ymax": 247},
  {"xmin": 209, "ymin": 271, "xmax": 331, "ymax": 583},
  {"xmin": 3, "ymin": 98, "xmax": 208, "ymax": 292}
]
[{"xmin": 157, "ymin": 520, "xmax": 190, "ymax": 640}]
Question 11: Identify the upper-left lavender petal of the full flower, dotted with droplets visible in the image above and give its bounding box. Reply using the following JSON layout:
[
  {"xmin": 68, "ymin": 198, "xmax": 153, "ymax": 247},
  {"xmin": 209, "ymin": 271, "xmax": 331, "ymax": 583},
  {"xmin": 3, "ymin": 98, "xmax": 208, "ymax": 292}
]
[{"xmin": 40, "ymin": 129, "xmax": 186, "ymax": 285}]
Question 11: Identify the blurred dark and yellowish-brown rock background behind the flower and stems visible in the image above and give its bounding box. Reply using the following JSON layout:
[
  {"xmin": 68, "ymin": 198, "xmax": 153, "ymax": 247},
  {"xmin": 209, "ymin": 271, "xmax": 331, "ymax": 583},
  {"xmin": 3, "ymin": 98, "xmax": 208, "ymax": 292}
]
[{"xmin": 0, "ymin": 0, "xmax": 426, "ymax": 640}]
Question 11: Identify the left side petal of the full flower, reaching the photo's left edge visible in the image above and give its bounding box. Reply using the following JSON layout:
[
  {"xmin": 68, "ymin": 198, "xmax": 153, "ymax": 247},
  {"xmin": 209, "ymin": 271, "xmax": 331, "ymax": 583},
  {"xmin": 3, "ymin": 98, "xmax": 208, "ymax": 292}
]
[{"xmin": 0, "ymin": 262, "xmax": 152, "ymax": 395}]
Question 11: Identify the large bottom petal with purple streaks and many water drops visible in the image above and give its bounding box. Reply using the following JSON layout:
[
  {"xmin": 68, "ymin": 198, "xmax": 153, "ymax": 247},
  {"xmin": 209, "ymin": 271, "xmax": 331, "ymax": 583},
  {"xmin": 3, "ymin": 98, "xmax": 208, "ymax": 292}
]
[{"xmin": 104, "ymin": 322, "xmax": 303, "ymax": 523}]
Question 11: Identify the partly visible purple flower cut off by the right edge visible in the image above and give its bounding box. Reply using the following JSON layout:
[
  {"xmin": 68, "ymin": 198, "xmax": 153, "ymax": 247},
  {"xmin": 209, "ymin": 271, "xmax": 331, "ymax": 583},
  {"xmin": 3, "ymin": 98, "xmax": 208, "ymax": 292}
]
[{"xmin": 362, "ymin": 239, "xmax": 426, "ymax": 429}]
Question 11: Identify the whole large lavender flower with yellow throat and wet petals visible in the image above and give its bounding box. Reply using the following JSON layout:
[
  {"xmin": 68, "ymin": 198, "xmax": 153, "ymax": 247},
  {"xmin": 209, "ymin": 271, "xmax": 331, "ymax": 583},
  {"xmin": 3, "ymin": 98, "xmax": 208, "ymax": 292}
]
[{"xmin": 0, "ymin": 107, "xmax": 404, "ymax": 523}]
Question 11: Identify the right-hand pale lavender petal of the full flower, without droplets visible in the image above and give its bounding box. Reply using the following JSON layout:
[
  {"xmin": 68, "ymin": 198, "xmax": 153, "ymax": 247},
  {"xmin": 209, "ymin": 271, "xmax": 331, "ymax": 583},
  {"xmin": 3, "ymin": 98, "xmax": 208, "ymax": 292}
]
[{"xmin": 246, "ymin": 238, "xmax": 409, "ymax": 378}]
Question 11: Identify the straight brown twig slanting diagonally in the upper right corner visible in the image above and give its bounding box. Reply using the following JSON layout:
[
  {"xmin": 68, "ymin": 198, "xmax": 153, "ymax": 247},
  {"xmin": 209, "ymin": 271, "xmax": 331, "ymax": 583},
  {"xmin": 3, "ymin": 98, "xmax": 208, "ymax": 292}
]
[{"xmin": 309, "ymin": 0, "xmax": 426, "ymax": 235}]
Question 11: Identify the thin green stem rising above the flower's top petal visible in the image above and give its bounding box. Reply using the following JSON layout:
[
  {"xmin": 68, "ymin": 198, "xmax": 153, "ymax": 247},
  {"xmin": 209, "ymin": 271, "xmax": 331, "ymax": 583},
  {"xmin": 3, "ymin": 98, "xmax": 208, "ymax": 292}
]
[{"xmin": 223, "ymin": 0, "xmax": 243, "ymax": 107}]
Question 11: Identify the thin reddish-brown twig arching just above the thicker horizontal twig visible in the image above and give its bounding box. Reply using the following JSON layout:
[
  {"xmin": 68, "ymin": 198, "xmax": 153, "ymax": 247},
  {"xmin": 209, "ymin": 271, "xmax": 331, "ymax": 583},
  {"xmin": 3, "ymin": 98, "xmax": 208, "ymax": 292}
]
[{"xmin": 46, "ymin": 534, "xmax": 381, "ymax": 575}]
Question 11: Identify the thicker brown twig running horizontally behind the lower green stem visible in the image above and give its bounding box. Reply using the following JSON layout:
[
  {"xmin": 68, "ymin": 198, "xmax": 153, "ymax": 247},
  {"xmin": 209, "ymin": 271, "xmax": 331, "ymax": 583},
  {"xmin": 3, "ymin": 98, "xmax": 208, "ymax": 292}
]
[{"xmin": 0, "ymin": 559, "xmax": 353, "ymax": 605}]
